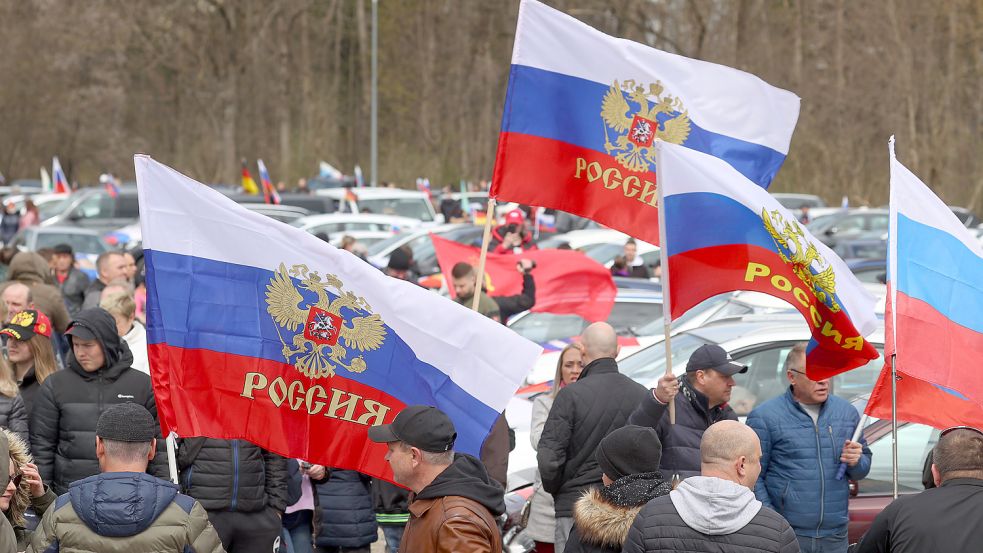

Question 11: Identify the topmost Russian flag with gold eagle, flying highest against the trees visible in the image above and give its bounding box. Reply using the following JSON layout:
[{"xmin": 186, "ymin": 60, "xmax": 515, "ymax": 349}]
[{"xmin": 491, "ymin": 0, "xmax": 799, "ymax": 244}]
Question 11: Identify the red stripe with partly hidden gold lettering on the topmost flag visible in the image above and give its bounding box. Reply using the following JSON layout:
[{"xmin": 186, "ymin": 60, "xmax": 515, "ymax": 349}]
[{"xmin": 491, "ymin": 132, "xmax": 659, "ymax": 244}]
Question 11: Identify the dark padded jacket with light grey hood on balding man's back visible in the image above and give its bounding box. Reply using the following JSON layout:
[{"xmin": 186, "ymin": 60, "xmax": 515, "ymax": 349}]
[{"xmin": 623, "ymin": 476, "xmax": 799, "ymax": 553}]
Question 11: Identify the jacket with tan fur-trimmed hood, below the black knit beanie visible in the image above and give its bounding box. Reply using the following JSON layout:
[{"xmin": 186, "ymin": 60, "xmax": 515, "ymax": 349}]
[{"xmin": 564, "ymin": 472, "xmax": 672, "ymax": 553}]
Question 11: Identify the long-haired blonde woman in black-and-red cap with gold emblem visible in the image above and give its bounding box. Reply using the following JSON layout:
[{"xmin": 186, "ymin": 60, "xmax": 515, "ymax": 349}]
[{"xmin": 0, "ymin": 309, "xmax": 60, "ymax": 416}]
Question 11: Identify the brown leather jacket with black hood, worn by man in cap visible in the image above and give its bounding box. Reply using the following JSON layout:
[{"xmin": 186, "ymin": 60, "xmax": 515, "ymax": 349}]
[{"xmin": 399, "ymin": 453, "xmax": 505, "ymax": 553}]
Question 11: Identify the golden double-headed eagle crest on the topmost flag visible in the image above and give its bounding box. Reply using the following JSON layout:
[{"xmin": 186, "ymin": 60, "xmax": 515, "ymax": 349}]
[{"xmin": 601, "ymin": 80, "xmax": 690, "ymax": 172}]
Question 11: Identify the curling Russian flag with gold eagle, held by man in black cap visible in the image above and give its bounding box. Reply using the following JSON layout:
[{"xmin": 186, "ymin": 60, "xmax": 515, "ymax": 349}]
[{"xmin": 660, "ymin": 144, "xmax": 878, "ymax": 380}]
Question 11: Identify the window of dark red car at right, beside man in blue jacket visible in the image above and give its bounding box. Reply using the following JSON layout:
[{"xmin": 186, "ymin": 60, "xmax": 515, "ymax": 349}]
[{"xmin": 859, "ymin": 424, "xmax": 940, "ymax": 495}]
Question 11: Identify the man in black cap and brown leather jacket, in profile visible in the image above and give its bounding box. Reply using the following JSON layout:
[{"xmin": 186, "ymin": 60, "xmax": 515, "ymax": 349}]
[{"xmin": 369, "ymin": 405, "xmax": 505, "ymax": 553}]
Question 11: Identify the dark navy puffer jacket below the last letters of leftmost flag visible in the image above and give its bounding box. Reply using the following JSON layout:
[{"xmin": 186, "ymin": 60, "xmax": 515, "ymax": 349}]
[{"xmin": 314, "ymin": 469, "xmax": 379, "ymax": 549}]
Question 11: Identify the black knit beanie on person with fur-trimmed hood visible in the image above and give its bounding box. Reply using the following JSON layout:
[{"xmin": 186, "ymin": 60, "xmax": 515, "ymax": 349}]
[{"xmin": 595, "ymin": 425, "xmax": 662, "ymax": 480}]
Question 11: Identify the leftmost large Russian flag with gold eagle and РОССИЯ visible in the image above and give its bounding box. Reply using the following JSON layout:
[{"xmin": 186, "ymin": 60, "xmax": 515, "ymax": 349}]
[{"xmin": 134, "ymin": 155, "xmax": 541, "ymax": 478}]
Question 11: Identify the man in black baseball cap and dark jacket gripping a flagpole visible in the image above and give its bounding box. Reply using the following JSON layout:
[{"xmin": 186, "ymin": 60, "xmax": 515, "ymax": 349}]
[{"xmin": 628, "ymin": 344, "xmax": 747, "ymax": 478}]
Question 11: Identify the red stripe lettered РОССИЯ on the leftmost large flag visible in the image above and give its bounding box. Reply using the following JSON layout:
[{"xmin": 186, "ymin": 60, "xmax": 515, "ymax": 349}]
[{"xmin": 148, "ymin": 344, "xmax": 405, "ymax": 481}]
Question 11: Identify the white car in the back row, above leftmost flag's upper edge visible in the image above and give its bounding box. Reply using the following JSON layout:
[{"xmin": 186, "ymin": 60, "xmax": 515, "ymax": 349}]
[{"xmin": 315, "ymin": 188, "xmax": 439, "ymax": 223}]
